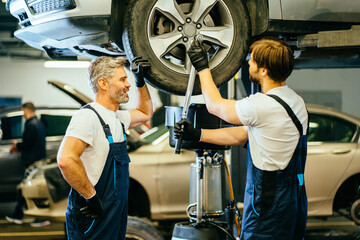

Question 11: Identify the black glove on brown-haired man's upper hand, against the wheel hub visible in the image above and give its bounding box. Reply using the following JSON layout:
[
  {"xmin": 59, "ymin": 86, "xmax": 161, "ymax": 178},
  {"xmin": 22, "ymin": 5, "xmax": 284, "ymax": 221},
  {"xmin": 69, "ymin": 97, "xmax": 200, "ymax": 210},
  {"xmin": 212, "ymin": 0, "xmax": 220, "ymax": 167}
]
[{"xmin": 187, "ymin": 40, "xmax": 209, "ymax": 72}]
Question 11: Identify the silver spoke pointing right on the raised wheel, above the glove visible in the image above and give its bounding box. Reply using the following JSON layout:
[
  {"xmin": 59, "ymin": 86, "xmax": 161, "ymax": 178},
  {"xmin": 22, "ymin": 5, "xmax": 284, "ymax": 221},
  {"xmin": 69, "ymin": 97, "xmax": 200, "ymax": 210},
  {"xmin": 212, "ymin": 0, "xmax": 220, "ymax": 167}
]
[{"xmin": 200, "ymin": 26, "xmax": 234, "ymax": 48}]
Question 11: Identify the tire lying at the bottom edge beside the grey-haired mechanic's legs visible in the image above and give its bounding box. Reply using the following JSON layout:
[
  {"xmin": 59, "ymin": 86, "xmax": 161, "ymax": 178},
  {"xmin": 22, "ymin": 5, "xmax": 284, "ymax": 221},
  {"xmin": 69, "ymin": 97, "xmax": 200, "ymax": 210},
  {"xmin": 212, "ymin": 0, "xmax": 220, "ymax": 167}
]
[{"xmin": 126, "ymin": 216, "xmax": 164, "ymax": 240}]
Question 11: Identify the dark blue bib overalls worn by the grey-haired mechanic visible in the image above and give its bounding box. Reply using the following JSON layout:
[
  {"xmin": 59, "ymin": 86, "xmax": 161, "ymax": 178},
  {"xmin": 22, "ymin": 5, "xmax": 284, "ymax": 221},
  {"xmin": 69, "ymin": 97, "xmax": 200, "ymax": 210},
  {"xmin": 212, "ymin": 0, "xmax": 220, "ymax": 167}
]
[{"xmin": 66, "ymin": 105, "xmax": 130, "ymax": 240}]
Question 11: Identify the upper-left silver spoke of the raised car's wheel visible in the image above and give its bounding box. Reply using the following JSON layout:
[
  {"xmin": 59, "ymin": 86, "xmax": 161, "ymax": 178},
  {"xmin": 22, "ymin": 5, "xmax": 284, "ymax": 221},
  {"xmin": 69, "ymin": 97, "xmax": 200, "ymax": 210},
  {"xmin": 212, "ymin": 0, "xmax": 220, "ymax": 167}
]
[{"xmin": 154, "ymin": 0, "xmax": 185, "ymax": 24}]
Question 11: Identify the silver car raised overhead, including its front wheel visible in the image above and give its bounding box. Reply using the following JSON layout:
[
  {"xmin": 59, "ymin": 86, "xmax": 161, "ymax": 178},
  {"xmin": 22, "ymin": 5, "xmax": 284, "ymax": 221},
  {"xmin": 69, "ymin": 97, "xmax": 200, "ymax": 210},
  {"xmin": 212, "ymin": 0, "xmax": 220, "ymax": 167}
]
[{"xmin": 6, "ymin": 0, "xmax": 360, "ymax": 95}]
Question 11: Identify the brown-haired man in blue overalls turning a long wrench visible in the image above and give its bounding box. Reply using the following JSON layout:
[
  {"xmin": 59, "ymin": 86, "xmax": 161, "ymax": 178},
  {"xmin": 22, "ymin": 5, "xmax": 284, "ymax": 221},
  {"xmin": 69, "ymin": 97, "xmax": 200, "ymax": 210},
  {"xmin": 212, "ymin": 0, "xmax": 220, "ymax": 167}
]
[{"xmin": 174, "ymin": 38, "xmax": 308, "ymax": 240}]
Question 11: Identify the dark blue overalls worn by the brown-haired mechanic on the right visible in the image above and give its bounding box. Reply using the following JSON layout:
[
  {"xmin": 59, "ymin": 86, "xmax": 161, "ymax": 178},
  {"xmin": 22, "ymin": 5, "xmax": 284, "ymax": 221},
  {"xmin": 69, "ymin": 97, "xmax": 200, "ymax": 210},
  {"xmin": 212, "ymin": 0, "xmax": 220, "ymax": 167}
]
[{"xmin": 241, "ymin": 95, "xmax": 307, "ymax": 240}]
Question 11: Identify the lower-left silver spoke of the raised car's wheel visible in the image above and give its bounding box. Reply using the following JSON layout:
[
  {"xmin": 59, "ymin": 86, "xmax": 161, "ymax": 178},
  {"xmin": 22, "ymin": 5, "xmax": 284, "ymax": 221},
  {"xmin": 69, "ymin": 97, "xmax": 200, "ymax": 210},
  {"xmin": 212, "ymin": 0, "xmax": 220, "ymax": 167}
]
[{"xmin": 149, "ymin": 32, "xmax": 182, "ymax": 58}]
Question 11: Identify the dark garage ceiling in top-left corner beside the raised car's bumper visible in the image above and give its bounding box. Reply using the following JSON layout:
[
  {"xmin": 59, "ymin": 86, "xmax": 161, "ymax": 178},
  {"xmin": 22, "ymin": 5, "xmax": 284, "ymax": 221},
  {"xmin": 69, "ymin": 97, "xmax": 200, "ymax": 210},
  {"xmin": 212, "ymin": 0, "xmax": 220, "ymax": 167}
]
[{"xmin": 0, "ymin": 2, "xmax": 49, "ymax": 59}]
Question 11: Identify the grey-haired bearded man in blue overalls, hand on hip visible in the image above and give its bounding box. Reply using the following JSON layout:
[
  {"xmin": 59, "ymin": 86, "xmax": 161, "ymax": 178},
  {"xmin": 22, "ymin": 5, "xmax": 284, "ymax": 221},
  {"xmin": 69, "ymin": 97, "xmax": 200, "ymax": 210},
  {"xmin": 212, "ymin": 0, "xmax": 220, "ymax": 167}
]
[{"xmin": 57, "ymin": 57, "xmax": 153, "ymax": 240}]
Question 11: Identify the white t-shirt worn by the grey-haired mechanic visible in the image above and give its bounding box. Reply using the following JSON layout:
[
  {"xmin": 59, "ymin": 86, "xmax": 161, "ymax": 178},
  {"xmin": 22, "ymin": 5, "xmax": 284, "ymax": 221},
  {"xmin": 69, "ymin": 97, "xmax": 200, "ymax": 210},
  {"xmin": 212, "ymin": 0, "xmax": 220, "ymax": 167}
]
[{"xmin": 62, "ymin": 102, "xmax": 131, "ymax": 186}]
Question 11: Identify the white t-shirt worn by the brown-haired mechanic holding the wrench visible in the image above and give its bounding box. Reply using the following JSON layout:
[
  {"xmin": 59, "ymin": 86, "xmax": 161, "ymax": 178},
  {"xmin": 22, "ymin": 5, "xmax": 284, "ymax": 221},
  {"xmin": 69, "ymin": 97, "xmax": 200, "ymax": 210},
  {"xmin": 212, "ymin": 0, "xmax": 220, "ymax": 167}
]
[{"xmin": 235, "ymin": 86, "xmax": 308, "ymax": 171}]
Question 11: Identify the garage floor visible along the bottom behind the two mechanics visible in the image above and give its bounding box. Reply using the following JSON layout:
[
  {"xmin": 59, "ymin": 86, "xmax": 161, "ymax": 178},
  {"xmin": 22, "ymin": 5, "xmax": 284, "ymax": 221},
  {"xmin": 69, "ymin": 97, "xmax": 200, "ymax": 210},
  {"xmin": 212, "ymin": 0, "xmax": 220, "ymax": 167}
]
[{"xmin": 0, "ymin": 203, "xmax": 360, "ymax": 240}]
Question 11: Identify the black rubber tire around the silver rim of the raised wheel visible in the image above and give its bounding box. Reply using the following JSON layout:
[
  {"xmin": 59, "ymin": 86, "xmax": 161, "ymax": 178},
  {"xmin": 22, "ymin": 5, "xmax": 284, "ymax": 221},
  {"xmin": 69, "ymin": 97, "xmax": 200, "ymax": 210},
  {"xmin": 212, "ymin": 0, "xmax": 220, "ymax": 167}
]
[{"xmin": 123, "ymin": 0, "xmax": 251, "ymax": 95}]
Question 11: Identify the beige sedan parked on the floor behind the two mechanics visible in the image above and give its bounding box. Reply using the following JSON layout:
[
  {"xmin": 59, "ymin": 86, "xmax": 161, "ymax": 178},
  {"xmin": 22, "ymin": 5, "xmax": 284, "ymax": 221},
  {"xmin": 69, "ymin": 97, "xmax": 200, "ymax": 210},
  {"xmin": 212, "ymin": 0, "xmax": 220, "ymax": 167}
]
[{"xmin": 21, "ymin": 82, "xmax": 360, "ymax": 227}]
